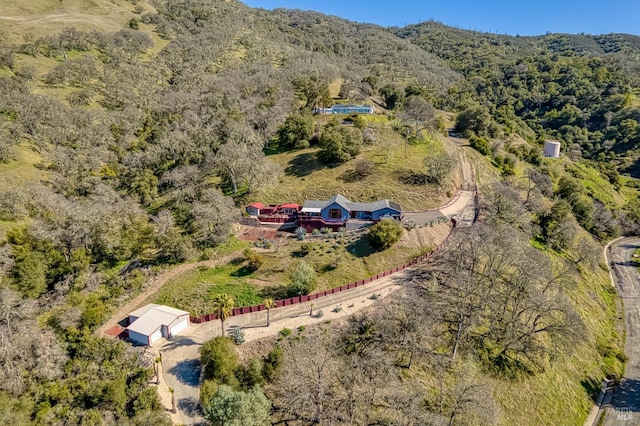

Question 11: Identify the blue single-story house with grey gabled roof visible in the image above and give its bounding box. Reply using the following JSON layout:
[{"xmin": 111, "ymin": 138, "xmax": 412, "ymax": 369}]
[{"xmin": 300, "ymin": 194, "xmax": 402, "ymax": 228}]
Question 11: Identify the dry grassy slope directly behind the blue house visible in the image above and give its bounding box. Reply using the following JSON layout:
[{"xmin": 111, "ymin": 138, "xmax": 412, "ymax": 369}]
[{"xmin": 258, "ymin": 127, "xmax": 459, "ymax": 210}]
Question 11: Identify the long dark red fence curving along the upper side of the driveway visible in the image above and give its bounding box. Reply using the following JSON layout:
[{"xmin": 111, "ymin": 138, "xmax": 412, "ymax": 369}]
[{"xmin": 191, "ymin": 229, "xmax": 453, "ymax": 323}]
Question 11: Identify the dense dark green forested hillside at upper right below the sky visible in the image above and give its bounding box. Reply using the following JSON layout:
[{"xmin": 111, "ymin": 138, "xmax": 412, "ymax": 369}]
[{"xmin": 393, "ymin": 22, "xmax": 640, "ymax": 176}]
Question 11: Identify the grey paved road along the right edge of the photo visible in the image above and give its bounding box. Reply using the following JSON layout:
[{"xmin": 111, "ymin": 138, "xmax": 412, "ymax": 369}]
[{"xmin": 602, "ymin": 238, "xmax": 640, "ymax": 426}]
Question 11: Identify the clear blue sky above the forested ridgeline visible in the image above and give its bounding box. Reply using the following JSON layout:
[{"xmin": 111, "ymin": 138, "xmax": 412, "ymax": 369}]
[{"xmin": 242, "ymin": 0, "xmax": 640, "ymax": 35}]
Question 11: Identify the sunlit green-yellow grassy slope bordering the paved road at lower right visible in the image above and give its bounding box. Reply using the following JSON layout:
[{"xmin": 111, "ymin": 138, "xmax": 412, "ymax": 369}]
[{"xmin": 493, "ymin": 262, "xmax": 626, "ymax": 426}]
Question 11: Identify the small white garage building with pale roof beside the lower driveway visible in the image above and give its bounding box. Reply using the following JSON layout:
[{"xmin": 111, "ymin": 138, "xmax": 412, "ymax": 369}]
[{"xmin": 127, "ymin": 303, "xmax": 189, "ymax": 345}]
